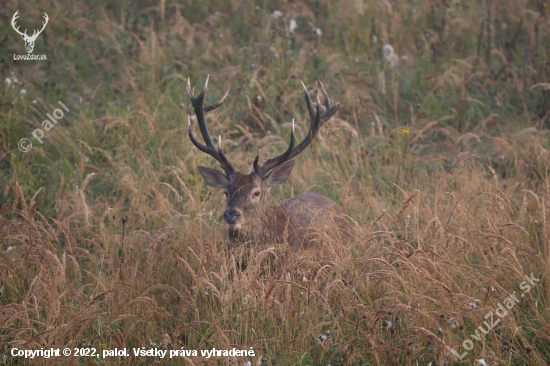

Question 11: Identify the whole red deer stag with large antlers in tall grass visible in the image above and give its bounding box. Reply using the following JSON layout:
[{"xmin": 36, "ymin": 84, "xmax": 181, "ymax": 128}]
[{"xmin": 187, "ymin": 78, "xmax": 347, "ymax": 249}]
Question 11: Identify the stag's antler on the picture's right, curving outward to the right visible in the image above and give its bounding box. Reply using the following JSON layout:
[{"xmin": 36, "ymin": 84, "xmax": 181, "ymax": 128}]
[{"xmin": 254, "ymin": 80, "xmax": 340, "ymax": 176}]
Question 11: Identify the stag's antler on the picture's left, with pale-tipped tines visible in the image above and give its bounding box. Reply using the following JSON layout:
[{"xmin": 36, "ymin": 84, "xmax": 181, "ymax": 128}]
[{"xmin": 187, "ymin": 76, "xmax": 235, "ymax": 175}]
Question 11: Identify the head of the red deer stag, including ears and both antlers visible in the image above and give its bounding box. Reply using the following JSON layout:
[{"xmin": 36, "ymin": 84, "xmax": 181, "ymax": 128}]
[{"xmin": 187, "ymin": 78, "xmax": 339, "ymax": 235}]
